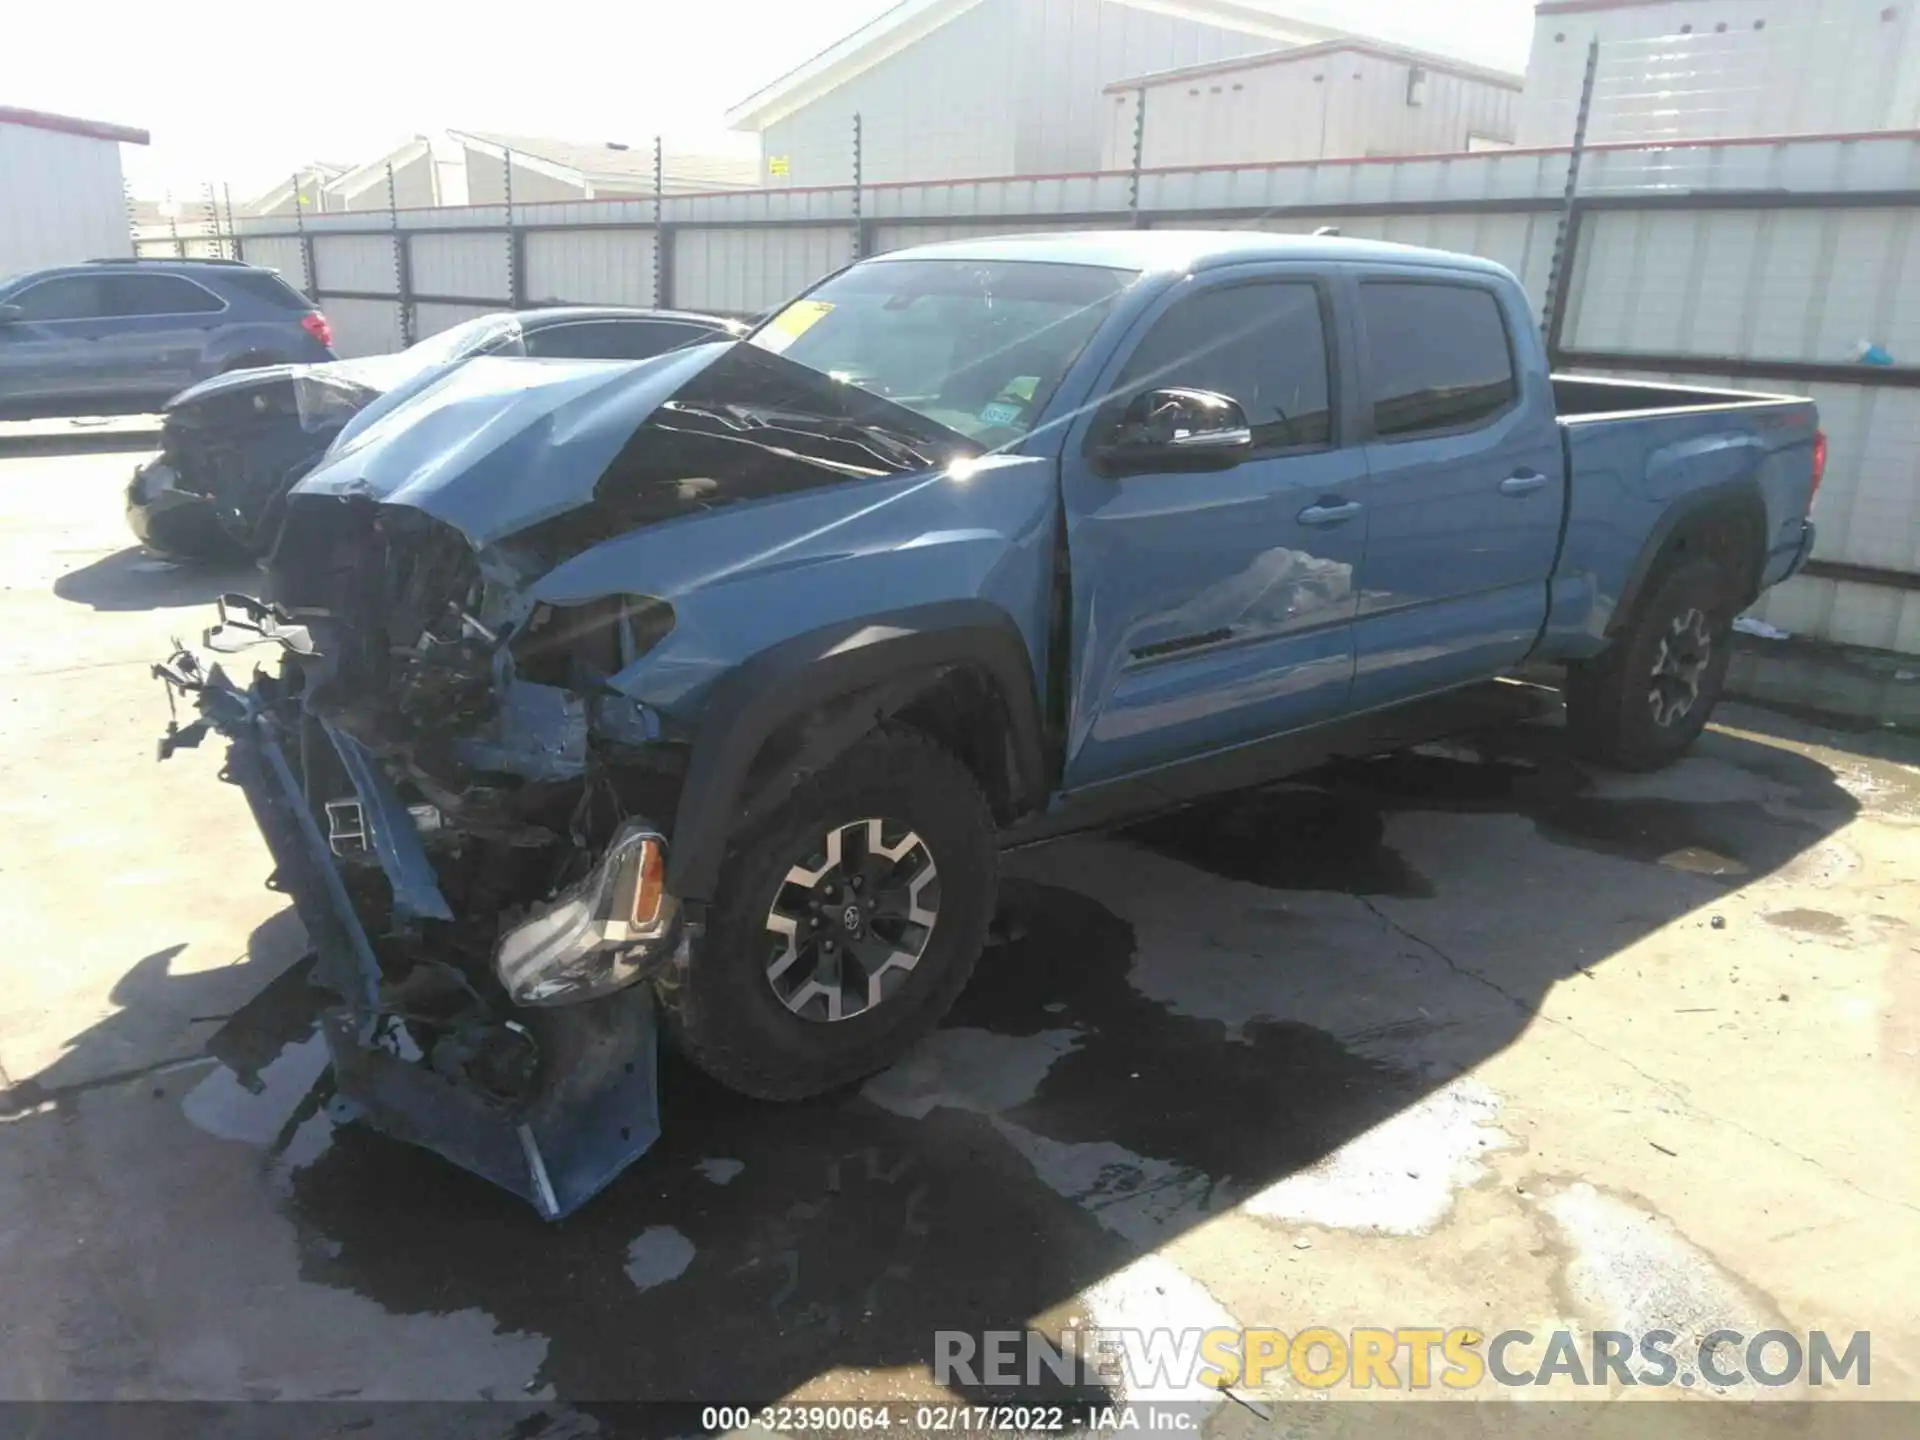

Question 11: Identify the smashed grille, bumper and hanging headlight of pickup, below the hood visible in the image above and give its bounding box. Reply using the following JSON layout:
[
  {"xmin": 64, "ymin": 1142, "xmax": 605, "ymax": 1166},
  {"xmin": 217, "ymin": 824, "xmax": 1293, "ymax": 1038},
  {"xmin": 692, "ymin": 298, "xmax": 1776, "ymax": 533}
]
[{"xmin": 156, "ymin": 549, "xmax": 691, "ymax": 1219}]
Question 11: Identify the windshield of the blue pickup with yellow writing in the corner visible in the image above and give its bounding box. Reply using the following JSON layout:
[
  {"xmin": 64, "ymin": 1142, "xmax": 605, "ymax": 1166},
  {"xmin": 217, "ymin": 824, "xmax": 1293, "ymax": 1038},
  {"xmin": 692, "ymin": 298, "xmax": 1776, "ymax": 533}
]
[{"xmin": 749, "ymin": 259, "xmax": 1137, "ymax": 447}]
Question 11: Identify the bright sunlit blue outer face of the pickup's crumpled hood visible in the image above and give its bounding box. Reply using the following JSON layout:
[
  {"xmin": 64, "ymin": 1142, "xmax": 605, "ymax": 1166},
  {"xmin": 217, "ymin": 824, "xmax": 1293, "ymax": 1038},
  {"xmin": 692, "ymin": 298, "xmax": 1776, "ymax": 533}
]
[{"xmin": 294, "ymin": 342, "xmax": 732, "ymax": 549}]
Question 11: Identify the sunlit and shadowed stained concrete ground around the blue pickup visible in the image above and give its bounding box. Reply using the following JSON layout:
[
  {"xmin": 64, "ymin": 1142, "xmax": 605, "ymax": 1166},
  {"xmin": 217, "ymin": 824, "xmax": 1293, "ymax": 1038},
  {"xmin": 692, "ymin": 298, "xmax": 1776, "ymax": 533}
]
[{"xmin": 0, "ymin": 440, "xmax": 1920, "ymax": 1434}]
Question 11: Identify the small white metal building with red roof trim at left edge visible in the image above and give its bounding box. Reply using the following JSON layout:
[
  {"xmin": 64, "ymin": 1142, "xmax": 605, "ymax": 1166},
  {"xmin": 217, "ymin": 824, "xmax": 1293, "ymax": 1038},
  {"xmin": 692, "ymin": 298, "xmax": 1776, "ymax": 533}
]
[{"xmin": 0, "ymin": 106, "xmax": 150, "ymax": 275}]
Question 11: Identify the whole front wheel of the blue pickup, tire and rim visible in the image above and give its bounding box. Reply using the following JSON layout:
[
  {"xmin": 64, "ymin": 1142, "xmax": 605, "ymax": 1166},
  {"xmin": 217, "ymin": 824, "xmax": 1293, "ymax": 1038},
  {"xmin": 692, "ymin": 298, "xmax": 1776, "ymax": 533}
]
[{"xmin": 660, "ymin": 730, "xmax": 998, "ymax": 1100}]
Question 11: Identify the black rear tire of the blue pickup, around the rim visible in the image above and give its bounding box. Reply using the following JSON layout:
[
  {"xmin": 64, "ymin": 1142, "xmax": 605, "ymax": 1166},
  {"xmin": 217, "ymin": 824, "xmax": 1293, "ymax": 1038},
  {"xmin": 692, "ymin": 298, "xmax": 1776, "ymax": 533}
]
[{"xmin": 1567, "ymin": 559, "xmax": 1734, "ymax": 770}]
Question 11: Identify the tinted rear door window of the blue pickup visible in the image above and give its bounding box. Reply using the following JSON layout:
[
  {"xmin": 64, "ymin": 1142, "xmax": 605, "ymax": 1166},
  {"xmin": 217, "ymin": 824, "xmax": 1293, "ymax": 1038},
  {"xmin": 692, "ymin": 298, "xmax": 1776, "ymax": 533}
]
[{"xmin": 1359, "ymin": 280, "xmax": 1519, "ymax": 440}]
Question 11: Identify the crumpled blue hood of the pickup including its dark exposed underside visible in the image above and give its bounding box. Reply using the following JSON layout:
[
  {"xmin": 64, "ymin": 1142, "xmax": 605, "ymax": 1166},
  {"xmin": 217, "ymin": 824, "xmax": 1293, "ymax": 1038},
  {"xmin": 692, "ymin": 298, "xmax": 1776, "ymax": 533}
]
[{"xmin": 290, "ymin": 340, "xmax": 981, "ymax": 572}]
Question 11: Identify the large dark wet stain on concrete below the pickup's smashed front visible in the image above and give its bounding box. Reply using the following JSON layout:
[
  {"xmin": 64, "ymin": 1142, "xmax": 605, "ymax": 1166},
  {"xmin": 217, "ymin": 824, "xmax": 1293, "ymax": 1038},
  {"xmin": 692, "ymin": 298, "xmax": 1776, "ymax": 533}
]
[{"xmin": 191, "ymin": 881, "xmax": 1421, "ymax": 1402}]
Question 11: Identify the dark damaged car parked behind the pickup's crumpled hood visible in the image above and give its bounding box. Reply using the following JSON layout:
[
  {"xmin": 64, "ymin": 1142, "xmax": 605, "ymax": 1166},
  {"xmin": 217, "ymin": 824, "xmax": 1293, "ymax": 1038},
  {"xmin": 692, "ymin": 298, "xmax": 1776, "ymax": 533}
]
[{"xmin": 127, "ymin": 305, "xmax": 745, "ymax": 559}]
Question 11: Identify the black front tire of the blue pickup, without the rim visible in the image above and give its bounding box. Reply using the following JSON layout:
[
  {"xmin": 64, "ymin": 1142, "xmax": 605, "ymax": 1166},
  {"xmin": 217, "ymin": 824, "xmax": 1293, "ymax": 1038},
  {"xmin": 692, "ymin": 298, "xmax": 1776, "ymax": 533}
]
[{"xmin": 659, "ymin": 726, "xmax": 998, "ymax": 1100}]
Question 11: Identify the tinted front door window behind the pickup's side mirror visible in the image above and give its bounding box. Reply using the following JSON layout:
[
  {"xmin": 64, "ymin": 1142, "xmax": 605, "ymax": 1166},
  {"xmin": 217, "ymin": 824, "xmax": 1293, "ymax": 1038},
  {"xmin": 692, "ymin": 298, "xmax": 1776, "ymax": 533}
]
[{"xmin": 1119, "ymin": 280, "xmax": 1332, "ymax": 449}]
